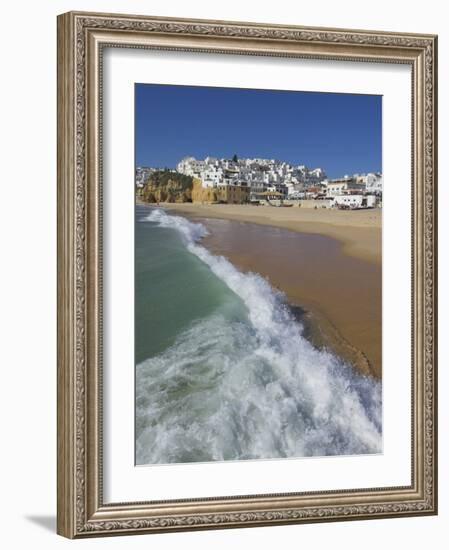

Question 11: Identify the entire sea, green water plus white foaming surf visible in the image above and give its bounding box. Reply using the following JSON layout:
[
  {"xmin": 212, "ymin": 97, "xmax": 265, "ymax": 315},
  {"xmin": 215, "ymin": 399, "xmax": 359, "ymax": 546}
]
[{"xmin": 135, "ymin": 205, "xmax": 382, "ymax": 465}]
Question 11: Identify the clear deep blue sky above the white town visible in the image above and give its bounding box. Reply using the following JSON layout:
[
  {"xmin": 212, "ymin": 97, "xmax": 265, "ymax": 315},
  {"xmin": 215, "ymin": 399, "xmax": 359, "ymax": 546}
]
[{"xmin": 135, "ymin": 84, "xmax": 382, "ymax": 177}]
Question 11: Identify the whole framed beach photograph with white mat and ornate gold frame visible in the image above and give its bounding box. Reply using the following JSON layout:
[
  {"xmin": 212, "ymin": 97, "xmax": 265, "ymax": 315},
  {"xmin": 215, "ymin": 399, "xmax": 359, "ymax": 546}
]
[{"xmin": 58, "ymin": 12, "xmax": 437, "ymax": 538}]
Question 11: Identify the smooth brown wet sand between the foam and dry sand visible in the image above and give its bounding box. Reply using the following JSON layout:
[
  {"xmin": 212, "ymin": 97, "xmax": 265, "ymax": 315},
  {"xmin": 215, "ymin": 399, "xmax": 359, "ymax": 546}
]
[{"xmin": 189, "ymin": 216, "xmax": 382, "ymax": 378}]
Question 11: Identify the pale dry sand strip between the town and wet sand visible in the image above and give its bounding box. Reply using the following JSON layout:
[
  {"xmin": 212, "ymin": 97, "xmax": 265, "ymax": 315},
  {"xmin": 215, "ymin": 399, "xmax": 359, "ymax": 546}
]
[{"xmin": 161, "ymin": 203, "xmax": 382, "ymax": 265}]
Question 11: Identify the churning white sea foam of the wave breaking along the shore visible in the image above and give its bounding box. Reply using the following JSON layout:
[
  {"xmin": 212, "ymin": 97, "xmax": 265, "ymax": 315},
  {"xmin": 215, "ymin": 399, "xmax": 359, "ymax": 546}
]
[{"xmin": 136, "ymin": 209, "xmax": 382, "ymax": 464}]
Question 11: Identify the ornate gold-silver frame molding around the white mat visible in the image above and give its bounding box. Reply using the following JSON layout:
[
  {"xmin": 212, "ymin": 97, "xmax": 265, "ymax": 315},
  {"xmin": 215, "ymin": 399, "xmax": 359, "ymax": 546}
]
[{"xmin": 57, "ymin": 12, "xmax": 437, "ymax": 538}]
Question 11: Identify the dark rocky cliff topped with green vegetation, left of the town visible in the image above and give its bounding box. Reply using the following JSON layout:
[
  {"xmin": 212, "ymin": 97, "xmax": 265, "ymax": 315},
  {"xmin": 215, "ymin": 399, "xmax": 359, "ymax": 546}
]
[{"xmin": 139, "ymin": 170, "xmax": 193, "ymax": 202}]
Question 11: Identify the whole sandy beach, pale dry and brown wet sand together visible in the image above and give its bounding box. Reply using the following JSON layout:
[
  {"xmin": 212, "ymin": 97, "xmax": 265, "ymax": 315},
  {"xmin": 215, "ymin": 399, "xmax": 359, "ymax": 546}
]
[{"xmin": 163, "ymin": 204, "xmax": 382, "ymax": 378}]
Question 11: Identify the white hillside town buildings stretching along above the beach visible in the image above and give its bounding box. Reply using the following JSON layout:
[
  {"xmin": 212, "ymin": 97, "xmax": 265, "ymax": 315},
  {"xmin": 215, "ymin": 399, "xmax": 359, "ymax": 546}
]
[{"xmin": 136, "ymin": 155, "xmax": 383, "ymax": 209}]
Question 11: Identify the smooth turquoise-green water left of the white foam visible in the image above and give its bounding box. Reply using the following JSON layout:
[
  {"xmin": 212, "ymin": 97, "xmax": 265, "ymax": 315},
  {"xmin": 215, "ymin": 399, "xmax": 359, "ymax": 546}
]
[{"xmin": 135, "ymin": 206, "xmax": 245, "ymax": 364}]
